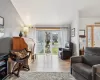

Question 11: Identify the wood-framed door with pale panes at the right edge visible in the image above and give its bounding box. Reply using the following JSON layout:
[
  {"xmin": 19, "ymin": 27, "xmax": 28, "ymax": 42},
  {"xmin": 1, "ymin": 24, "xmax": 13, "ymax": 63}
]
[{"xmin": 86, "ymin": 25, "xmax": 100, "ymax": 47}]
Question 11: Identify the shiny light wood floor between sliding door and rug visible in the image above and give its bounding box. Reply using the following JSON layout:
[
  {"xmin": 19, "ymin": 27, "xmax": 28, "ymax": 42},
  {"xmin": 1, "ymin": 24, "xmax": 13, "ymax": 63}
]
[{"xmin": 30, "ymin": 55, "xmax": 70, "ymax": 72}]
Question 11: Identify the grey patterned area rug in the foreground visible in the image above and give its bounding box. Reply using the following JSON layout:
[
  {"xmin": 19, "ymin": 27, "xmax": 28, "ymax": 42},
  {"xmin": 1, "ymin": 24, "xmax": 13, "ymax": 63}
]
[{"xmin": 8, "ymin": 72, "xmax": 76, "ymax": 80}]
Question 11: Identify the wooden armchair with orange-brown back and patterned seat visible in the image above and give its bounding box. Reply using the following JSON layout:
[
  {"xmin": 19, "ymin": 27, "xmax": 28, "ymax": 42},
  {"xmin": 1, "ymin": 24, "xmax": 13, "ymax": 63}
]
[{"xmin": 10, "ymin": 37, "xmax": 31, "ymax": 77}]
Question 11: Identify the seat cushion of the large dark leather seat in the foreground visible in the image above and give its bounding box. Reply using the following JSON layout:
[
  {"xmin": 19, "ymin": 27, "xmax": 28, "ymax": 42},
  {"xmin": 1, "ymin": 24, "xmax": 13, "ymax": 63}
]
[{"xmin": 72, "ymin": 63, "xmax": 92, "ymax": 80}]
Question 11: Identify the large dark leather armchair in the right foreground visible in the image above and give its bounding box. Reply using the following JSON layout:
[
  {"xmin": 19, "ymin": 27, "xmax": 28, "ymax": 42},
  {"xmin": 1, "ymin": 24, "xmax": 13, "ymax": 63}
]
[{"xmin": 71, "ymin": 47, "xmax": 100, "ymax": 80}]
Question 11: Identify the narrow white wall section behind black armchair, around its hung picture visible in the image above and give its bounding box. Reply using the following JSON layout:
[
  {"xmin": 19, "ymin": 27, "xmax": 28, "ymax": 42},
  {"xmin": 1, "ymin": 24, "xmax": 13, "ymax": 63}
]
[{"xmin": 71, "ymin": 12, "xmax": 79, "ymax": 56}]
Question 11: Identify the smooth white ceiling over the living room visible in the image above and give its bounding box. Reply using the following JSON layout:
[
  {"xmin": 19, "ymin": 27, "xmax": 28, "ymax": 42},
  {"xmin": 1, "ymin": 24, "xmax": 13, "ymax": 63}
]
[{"xmin": 11, "ymin": 0, "xmax": 100, "ymax": 25}]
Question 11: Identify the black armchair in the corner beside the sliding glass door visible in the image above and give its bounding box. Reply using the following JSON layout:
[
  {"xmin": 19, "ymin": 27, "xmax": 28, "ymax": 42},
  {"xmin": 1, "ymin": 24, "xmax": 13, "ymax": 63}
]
[{"xmin": 58, "ymin": 42, "xmax": 73, "ymax": 60}]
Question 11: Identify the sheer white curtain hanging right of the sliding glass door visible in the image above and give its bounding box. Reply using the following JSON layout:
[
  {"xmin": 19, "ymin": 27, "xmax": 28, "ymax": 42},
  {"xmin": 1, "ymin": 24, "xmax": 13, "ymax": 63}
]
[{"xmin": 59, "ymin": 27, "xmax": 68, "ymax": 47}]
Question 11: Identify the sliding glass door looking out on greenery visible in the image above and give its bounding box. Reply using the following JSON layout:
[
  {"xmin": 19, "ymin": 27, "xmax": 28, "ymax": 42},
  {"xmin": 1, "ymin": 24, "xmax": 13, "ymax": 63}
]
[{"xmin": 36, "ymin": 30, "xmax": 60, "ymax": 55}]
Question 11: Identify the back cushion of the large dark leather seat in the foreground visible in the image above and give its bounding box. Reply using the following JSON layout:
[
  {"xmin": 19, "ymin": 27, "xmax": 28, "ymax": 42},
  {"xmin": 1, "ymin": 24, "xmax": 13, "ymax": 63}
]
[{"xmin": 83, "ymin": 47, "xmax": 100, "ymax": 66}]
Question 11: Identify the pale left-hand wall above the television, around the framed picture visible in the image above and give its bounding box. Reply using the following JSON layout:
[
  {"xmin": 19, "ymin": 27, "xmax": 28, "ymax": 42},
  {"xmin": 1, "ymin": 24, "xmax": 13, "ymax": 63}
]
[{"xmin": 0, "ymin": 0, "xmax": 24, "ymax": 37}]
